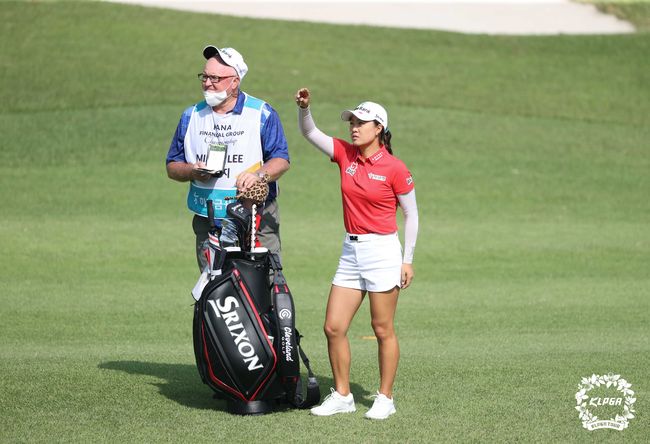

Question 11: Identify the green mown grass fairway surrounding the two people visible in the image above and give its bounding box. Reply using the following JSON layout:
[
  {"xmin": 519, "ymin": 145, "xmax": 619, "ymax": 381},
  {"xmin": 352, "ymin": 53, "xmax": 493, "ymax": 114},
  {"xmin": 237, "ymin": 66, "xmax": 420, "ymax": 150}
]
[{"xmin": 0, "ymin": 2, "xmax": 650, "ymax": 443}]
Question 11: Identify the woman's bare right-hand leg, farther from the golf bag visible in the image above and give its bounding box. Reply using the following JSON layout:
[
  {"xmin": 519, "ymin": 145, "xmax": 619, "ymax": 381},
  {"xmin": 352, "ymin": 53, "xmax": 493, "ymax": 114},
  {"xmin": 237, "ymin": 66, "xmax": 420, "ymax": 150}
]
[{"xmin": 368, "ymin": 287, "xmax": 399, "ymax": 398}]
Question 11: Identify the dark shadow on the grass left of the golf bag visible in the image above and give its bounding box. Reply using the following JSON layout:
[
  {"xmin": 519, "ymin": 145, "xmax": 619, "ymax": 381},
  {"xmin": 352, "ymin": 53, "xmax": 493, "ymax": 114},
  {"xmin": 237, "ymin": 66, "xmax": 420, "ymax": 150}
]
[{"xmin": 98, "ymin": 361, "xmax": 226, "ymax": 411}]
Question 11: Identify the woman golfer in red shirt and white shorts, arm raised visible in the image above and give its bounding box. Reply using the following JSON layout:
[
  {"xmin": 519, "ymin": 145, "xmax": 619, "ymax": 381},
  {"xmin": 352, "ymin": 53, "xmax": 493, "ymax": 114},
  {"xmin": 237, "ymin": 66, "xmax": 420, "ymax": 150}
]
[{"xmin": 296, "ymin": 88, "xmax": 418, "ymax": 419}]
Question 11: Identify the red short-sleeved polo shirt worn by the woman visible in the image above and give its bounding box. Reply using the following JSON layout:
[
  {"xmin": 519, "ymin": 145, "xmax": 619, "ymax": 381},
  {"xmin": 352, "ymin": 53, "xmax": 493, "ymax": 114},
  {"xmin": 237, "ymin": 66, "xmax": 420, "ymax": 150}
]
[{"xmin": 332, "ymin": 139, "xmax": 414, "ymax": 234}]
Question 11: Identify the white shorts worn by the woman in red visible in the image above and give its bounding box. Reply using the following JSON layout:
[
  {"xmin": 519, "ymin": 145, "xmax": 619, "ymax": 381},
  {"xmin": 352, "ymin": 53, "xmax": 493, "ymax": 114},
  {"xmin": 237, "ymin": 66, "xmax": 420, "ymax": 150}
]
[{"xmin": 332, "ymin": 233, "xmax": 402, "ymax": 292}]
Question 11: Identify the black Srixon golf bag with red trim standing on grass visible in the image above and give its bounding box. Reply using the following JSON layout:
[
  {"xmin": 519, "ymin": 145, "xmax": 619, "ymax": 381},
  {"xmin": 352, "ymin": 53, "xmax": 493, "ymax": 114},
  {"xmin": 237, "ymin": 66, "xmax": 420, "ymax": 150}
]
[{"xmin": 193, "ymin": 202, "xmax": 320, "ymax": 414}]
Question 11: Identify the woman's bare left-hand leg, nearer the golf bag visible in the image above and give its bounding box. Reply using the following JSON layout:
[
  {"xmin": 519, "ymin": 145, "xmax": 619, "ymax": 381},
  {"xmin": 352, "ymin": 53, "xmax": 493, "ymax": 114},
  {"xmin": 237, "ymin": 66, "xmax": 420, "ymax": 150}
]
[{"xmin": 324, "ymin": 285, "xmax": 364, "ymax": 396}]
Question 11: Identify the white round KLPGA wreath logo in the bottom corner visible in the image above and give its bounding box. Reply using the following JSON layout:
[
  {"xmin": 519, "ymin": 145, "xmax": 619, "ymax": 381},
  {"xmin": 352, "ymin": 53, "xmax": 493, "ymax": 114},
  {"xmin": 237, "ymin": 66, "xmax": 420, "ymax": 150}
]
[{"xmin": 576, "ymin": 373, "xmax": 636, "ymax": 431}]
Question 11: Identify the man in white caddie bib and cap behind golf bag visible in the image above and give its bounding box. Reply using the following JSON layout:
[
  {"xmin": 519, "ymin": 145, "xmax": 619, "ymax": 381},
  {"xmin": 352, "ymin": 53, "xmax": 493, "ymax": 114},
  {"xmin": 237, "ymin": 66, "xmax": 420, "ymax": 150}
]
[{"xmin": 167, "ymin": 45, "xmax": 289, "ymax": 271}]
